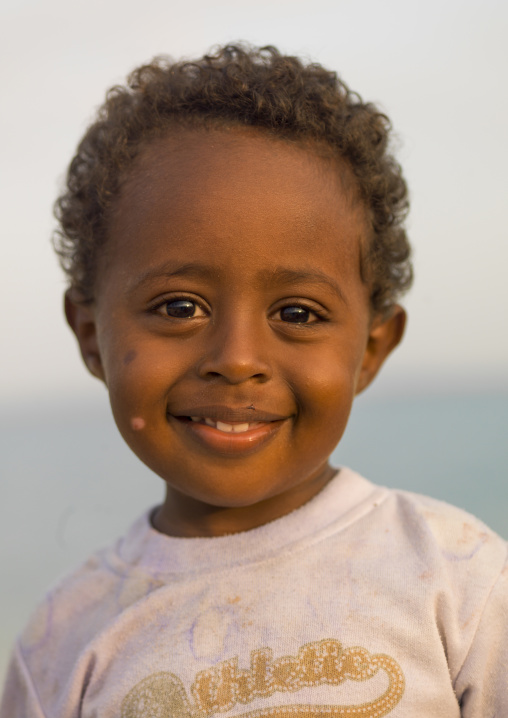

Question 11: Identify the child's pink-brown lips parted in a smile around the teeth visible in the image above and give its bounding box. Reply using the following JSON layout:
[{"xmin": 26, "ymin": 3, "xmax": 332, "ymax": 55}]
[{"xmin": 167, "ymin": 405, "xmax": 290, "ymax": 456}]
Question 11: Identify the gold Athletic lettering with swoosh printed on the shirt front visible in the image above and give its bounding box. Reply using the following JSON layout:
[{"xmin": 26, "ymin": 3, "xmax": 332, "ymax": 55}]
[{"xmin": 121, "ymin": 639, "xmax": 404, "ymax": 718}]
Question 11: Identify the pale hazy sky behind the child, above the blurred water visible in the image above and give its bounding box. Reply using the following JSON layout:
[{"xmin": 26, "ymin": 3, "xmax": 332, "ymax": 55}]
[{"xmin": 0, "ymin": 0, "xmax": 508, "ymax": 406}]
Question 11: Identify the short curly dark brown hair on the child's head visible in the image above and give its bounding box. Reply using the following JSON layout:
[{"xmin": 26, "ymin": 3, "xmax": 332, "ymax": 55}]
[{"xmin": 53, "ymin": 44, "xmax": 412, "ymax": 312}]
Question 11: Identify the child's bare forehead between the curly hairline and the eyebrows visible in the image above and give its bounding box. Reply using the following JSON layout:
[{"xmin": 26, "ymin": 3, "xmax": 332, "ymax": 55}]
[{"xmin": 106, "ymin": 128, "xmax": 367, "ymax": 296}]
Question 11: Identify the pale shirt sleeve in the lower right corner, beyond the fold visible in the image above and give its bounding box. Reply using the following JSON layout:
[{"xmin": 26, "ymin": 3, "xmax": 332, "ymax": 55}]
[{"xmin": 455, "ymin": 561, "xmax": 508, "ymax": 718}]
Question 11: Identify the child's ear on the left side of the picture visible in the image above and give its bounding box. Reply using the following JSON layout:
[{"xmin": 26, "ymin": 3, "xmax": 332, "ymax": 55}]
[{"xmin": 64, "ymin": 287, "xmax": 106, "ymax": 382}]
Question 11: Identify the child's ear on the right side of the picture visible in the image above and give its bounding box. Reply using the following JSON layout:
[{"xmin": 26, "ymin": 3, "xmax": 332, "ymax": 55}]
[{"xmin": 356, "ymin": 304, "xmax": 406, "ymax": 394}]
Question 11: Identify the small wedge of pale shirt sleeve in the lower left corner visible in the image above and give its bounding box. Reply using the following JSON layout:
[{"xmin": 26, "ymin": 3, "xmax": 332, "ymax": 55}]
[{"xmin": 0, "ymin": 646, "xmax": 47, "ymax": 718}]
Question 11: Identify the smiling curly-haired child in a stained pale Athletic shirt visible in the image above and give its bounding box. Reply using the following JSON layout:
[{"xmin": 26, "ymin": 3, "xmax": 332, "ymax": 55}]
[{"xmin": 0, "ymin": 47, "xmax": 508, "ymax": 718}]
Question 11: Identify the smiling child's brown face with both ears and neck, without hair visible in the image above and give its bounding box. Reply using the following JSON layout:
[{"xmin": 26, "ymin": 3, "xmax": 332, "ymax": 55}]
[{"xmin": 66, "ymin": 130, "xmax": 404, "ymax": 535}]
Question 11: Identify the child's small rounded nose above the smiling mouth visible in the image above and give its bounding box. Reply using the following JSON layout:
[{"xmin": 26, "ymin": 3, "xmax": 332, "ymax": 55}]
[{"xmin": 197, "ymin": 314, "xmax": 272, "ymax": 384}]
